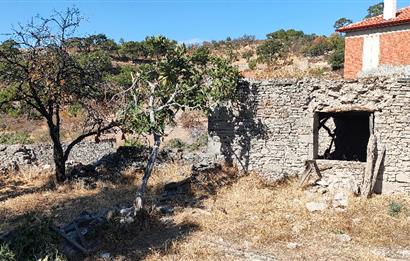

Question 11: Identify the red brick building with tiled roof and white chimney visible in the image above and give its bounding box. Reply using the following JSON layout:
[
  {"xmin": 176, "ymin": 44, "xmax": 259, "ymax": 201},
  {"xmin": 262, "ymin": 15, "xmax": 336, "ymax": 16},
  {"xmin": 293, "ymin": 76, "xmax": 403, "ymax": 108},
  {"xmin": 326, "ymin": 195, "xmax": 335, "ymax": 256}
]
[{"xmin": 338, "ymin": 0, "xmax": 410, "ymax": 79}]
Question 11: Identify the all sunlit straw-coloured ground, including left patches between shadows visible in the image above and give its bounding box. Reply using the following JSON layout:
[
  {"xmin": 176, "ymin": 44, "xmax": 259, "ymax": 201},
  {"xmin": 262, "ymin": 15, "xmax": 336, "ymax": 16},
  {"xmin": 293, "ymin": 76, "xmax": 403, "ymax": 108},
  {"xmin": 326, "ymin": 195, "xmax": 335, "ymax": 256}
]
[{"xmin": 0, "ymin": 164, "xmax": 410, "ymax": 260}]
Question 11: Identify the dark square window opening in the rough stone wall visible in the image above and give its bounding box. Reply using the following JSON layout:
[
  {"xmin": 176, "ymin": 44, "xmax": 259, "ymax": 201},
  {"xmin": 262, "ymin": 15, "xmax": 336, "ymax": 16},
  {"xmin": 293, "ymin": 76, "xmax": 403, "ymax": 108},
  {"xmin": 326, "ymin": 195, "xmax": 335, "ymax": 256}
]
[{"xmin": 314, "ymin": 111, "xmax": 373, "ymax": 162}]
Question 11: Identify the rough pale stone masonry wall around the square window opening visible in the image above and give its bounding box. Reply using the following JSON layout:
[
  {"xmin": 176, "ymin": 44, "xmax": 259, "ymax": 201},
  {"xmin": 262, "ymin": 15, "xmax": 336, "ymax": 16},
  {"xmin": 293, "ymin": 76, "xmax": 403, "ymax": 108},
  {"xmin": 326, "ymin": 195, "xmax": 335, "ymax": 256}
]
[{"xmin": 208, "ymin": 77, "xmax": 410, "ymax": 194}]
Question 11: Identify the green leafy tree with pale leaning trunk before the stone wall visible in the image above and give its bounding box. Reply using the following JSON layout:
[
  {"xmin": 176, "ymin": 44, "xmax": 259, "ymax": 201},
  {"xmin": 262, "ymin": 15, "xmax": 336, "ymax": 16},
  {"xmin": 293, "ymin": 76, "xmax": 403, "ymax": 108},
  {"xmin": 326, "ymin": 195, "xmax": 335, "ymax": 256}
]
[{"xmin": 119, "ymin": 36, "xmax": 239, "ymax": 213}]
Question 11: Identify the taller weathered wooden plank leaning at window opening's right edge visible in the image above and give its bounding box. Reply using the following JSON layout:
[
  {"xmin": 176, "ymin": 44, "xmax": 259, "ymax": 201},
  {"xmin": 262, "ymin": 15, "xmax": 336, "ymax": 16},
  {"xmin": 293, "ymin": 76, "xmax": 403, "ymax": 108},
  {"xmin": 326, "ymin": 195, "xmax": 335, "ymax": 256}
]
[{"xmin": 361, "ymin": 135, "xmax": 377, "ymax": 197}]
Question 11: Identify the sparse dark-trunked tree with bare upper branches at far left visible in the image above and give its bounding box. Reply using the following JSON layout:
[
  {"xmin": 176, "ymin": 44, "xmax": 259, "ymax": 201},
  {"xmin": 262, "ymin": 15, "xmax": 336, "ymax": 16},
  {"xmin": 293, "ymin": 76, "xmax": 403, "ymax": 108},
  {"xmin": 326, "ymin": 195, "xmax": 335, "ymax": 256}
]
[{"xmin": 0, "ymin": 8, "xmax": 117, "ymax": 182}]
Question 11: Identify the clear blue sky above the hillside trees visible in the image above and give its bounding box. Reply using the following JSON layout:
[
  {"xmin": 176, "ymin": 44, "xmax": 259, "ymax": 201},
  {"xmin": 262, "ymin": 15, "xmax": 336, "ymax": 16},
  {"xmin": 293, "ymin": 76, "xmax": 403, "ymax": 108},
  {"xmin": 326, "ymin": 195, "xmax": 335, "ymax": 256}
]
[{"xmin": 0, "ymin": 0, "xmax": 410, "ymax": 42}]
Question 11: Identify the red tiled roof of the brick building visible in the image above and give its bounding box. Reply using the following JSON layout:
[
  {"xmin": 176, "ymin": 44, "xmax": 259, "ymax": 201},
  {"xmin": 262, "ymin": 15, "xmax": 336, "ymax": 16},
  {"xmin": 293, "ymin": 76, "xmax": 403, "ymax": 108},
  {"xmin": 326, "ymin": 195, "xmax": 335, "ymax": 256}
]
[{"xmin": 337, "ymin": 6, "xmax": 410, "ymax": 32}]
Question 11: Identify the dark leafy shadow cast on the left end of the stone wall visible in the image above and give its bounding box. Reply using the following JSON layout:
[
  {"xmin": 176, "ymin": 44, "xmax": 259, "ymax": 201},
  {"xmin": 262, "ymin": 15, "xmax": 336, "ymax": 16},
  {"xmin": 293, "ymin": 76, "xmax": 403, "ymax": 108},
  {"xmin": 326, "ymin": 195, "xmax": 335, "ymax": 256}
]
[{"xmin": 208, "ymin": 82, "xmax": 268, "ymax": 171}]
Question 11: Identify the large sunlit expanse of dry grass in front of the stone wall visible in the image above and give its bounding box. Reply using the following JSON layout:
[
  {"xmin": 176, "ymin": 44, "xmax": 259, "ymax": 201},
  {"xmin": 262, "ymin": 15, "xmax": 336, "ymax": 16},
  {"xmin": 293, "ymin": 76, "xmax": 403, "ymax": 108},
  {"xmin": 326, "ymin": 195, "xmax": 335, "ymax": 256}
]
[{"xmin": 149, "ymin": 172, "xmax": 410, "ymax": 260}]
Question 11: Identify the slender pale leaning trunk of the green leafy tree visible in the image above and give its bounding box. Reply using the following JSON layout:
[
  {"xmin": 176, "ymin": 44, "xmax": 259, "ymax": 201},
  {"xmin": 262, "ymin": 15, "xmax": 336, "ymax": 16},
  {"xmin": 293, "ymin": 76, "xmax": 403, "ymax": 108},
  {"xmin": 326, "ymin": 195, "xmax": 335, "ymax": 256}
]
[{"xmin": 134, "ymin": 133, "xmax": 161, "ymax": 212}]
